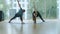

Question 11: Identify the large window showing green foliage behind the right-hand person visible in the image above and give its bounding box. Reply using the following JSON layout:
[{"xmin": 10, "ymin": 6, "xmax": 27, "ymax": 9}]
[{"xmin": 28, "ymin": 0, "xmax": 57, "ymax": 19}]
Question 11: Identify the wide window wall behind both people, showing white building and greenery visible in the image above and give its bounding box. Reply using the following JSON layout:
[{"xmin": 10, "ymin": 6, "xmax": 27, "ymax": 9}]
[{"xmin": 4, "ymin": 0, "xmax": 58, "ymax": 19}]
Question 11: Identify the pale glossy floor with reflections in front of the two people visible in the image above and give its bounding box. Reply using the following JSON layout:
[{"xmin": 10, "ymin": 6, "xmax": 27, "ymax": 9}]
[{"xmin": 0, "ymin": 21, "xmax": 60, "ymax": 34}]
